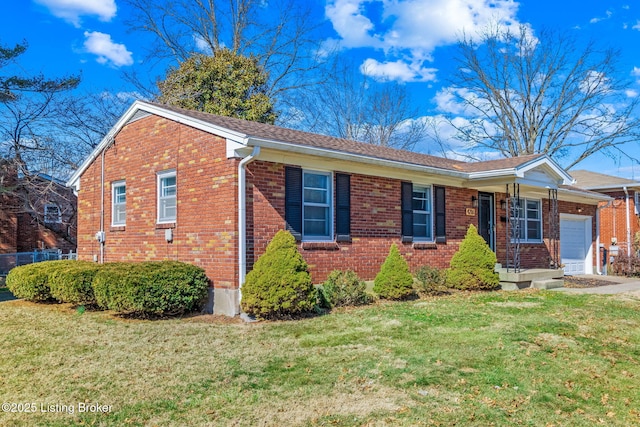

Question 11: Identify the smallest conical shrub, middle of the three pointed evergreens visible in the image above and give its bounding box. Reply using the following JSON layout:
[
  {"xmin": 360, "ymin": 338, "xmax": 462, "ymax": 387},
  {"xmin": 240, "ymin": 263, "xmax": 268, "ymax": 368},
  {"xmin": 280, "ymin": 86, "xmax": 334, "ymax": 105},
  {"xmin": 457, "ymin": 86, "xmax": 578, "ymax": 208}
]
[{"xmin": 373, "ymin": 243, "xmax": 413, "ymax": 299}]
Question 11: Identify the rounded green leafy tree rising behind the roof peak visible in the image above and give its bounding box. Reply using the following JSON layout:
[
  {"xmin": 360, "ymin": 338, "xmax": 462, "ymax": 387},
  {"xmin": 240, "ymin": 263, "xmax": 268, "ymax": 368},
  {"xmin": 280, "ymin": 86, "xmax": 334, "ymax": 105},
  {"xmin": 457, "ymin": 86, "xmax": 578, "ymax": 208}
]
[{"xmin": 158, "ymin": 49, "xmax": 277, "ymax": 124}]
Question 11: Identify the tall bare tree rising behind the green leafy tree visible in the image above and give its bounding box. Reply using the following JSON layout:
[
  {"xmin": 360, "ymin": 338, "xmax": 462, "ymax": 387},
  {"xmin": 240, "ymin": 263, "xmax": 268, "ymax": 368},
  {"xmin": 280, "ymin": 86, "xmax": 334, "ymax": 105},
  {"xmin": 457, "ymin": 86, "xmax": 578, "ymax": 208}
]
[{"xmin": 126, "ymin": 0, "xmax": 328, "ymax": 107}]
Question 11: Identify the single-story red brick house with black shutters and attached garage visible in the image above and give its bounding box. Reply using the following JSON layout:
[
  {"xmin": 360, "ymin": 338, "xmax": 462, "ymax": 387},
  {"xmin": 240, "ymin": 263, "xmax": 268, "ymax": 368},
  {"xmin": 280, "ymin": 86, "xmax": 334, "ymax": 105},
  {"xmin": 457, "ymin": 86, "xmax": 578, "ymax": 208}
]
[{"xmin": 68, "ymin": 101, "xmax": 606, "ymax": 315}]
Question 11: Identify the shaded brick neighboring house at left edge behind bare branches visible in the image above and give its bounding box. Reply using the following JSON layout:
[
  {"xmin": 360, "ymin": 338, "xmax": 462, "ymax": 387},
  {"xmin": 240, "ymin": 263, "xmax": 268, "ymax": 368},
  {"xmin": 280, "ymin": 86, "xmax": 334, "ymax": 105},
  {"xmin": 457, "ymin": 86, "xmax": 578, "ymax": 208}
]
[{"xmin": 0, "ymin": 162, "xmax": 77, "ymax": 253}]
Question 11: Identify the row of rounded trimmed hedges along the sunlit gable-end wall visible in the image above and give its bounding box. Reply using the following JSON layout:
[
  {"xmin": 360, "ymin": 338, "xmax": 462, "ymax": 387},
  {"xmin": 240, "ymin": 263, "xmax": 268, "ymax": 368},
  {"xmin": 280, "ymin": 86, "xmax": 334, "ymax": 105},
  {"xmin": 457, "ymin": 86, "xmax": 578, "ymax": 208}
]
[{"xmin": 7, "ymin": 261, "xmax": 209, "ymax": 315}]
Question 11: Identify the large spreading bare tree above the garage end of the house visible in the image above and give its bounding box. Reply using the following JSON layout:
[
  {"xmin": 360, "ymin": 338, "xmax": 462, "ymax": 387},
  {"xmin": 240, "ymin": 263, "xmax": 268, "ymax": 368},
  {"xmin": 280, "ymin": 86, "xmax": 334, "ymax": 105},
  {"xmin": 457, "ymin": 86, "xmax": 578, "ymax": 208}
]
[{"xmin": 450, "ymin": 26, "xmax": 640, "ymax": 169}]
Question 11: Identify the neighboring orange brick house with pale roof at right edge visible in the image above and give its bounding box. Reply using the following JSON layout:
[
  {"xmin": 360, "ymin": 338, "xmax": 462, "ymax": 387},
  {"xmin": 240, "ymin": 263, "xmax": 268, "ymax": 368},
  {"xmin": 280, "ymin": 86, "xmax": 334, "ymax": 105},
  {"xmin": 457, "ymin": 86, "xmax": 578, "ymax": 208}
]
[{"xmin": 571, "ymin": 170, "xmax": 640, "ymax": 268}]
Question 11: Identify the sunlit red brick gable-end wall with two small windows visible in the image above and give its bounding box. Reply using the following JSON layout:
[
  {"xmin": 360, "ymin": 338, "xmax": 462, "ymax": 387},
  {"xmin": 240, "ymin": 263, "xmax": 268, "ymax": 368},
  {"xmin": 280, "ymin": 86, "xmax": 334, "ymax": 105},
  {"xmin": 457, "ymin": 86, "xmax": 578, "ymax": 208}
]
[{"xmin": 78, "ymin": 116, "xmax": 238, "ymax": 288}]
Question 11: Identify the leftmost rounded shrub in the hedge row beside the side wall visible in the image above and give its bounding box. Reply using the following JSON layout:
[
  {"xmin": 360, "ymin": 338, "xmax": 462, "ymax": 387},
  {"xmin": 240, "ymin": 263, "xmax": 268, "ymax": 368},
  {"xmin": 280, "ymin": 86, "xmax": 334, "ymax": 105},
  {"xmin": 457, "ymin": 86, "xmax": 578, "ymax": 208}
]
[{"xmin": 6, "ymin": 260, "xmax": 77, "ymax": 302}]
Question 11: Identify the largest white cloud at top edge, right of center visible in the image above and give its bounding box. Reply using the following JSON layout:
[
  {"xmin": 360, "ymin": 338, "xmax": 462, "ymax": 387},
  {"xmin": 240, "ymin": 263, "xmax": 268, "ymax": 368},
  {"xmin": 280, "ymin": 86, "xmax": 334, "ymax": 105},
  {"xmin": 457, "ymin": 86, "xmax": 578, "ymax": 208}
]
[{"xmin": 325, "ymin": 0, "xmax": 520, "ymax": 81}]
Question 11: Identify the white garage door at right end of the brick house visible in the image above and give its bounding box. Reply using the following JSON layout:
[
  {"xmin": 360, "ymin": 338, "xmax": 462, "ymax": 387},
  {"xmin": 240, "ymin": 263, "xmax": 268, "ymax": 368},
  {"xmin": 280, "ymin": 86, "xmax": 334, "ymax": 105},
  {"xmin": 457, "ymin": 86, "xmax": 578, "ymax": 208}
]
[{"xmin": 560, "ymin": 215, "xmax": 593, "ymax": 274}]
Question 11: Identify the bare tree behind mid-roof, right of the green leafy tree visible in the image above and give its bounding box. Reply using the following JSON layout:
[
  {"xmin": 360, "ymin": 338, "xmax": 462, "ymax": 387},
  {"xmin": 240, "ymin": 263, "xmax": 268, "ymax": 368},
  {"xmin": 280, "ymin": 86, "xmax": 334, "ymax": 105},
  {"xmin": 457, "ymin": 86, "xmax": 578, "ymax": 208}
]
[{"xmin": 300, "ymin": 64, "xmax": 427, "ymax": 150}]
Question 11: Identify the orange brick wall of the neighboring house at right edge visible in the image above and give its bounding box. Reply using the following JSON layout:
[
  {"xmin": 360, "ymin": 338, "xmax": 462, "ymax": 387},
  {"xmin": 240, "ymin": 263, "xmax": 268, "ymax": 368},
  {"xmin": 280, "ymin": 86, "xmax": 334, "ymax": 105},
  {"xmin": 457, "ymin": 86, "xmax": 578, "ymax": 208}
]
[{"xmin": 600, "ymin": 191, "xmax": 640, "ymax": 251}]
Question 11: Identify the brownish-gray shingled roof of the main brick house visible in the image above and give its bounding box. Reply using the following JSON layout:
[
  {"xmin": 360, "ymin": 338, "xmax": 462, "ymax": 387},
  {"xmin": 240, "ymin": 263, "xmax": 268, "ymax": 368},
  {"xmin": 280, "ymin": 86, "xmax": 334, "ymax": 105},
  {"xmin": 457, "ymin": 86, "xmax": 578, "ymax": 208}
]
[{"xmin": 147, "ymin": 102, "xmax": 544, "ymax": 172}]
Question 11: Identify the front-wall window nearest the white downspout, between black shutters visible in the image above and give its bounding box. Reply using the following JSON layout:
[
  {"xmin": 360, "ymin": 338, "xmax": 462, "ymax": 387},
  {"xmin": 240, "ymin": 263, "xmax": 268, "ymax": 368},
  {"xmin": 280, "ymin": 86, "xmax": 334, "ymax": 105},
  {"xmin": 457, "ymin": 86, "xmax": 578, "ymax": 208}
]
[{"xmin": 302, "ymin": 171, "xmax": 333, "ymax": 240}]
